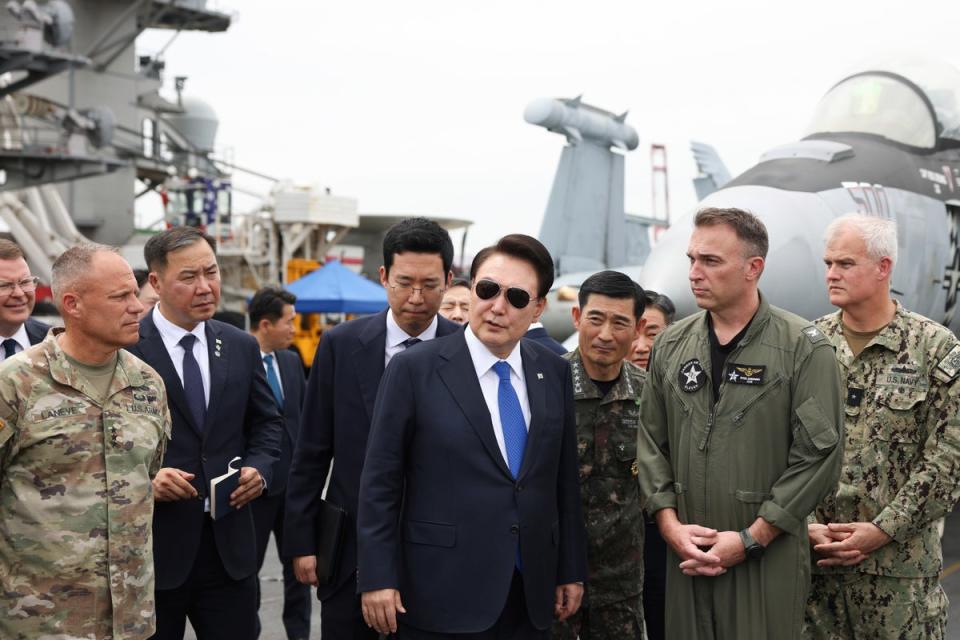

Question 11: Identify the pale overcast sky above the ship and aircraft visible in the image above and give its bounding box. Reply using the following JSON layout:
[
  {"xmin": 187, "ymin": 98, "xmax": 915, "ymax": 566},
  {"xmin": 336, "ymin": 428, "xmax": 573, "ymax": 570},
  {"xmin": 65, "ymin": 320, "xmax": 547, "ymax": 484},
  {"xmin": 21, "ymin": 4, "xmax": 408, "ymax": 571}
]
[{"xmin": 138, "ymin": 0, "xmax": 960, "ymax": 258}]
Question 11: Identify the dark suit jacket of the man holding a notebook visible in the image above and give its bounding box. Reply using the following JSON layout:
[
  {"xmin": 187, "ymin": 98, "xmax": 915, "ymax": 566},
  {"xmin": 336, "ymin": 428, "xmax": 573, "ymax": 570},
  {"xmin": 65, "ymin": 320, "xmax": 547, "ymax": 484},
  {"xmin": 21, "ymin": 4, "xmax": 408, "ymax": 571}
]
[{"xmin": 130, "ymin": 311, "xmax": 283, "ymax": 589}]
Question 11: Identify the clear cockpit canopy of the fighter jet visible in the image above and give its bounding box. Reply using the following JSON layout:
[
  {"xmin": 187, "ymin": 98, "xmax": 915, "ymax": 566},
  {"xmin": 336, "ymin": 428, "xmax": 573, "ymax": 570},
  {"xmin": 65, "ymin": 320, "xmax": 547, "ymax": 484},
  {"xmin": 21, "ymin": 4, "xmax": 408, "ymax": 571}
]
[{"xmin": 807, "ymin": 56, "xmax": 960, "ymax": 149}]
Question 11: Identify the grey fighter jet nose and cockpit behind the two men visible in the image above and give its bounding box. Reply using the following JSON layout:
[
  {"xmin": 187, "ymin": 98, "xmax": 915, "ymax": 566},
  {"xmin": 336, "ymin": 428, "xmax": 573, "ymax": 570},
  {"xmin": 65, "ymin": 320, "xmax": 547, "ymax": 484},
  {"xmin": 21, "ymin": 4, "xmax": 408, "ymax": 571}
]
[{"xmin": 640, "ymin": 60, "xmax": 960, "ymax": 332}]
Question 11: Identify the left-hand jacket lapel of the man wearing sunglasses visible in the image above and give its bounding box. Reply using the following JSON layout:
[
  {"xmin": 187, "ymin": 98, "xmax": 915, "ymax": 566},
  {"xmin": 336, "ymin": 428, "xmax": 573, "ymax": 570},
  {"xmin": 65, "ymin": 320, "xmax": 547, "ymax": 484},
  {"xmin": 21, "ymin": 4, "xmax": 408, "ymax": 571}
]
[{"xmin": 439, "ymin": 333, "xmax": 513, "ymax": 479}]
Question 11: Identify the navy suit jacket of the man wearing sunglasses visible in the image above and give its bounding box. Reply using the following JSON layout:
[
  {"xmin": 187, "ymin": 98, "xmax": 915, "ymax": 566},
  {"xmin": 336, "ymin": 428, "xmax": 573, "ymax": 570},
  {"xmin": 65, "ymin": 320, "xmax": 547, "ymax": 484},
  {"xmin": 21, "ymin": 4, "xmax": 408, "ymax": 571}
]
[{"xmin": 357, "ymin": 333, "xmax": 586, "ymax": 633}]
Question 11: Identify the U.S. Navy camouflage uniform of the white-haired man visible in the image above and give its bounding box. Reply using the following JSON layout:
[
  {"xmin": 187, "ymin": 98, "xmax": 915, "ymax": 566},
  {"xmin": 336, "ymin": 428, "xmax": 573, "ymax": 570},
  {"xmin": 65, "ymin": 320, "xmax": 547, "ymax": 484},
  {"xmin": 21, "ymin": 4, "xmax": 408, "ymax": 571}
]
[{"xmin": 805, "ymin": 304, "xmax": 960, "ymax": 639}]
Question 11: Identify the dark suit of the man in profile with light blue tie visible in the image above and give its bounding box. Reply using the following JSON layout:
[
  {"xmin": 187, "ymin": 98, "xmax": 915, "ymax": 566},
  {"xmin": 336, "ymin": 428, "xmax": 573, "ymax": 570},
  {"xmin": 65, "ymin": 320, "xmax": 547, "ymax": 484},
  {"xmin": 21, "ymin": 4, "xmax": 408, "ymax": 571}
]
[{"xmin": 250, "ymin": 349, "xmax": 311, "ymax": 638}]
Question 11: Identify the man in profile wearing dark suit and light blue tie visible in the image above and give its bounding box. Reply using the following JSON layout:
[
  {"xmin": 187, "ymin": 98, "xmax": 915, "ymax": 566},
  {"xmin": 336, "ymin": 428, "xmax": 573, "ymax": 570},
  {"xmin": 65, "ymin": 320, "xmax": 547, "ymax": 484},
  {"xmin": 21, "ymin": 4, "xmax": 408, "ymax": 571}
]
[{"xmin": 247, "ymin": 287, "xmax": 310, "ymax": 640}]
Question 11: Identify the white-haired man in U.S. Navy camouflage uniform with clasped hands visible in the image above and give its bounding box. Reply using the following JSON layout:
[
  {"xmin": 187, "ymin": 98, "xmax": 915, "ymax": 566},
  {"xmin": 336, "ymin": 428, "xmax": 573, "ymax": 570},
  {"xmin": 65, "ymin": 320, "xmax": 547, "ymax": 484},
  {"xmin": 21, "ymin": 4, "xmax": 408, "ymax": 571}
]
[{"xmin": 805, "ymin": 215, "xmax": 960, "ymax": 640}]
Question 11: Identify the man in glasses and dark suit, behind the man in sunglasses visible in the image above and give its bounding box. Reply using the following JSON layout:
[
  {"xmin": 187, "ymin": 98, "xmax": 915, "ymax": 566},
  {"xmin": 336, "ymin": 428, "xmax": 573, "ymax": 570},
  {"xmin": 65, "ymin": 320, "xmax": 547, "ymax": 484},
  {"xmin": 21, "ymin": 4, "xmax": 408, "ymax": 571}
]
[{"xmin": 284, "ymin": 218, "xmax": 460, "ymax": 640}]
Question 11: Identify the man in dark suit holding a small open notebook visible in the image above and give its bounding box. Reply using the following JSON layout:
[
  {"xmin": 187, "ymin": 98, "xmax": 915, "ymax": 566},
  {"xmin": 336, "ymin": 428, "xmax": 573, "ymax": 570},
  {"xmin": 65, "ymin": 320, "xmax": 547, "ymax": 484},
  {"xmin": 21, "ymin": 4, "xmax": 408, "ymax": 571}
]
[{"xmin": 130, "ymin": 227, "xmax": 283, "ymax": 640}]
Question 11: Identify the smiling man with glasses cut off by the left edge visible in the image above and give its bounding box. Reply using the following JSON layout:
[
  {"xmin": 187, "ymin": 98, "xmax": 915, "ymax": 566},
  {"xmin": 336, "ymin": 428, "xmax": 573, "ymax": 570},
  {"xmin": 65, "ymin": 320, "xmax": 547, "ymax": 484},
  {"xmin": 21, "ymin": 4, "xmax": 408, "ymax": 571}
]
[{"xmin": 0, "ymin": 238, "xmax": 50, "ymax": 362}]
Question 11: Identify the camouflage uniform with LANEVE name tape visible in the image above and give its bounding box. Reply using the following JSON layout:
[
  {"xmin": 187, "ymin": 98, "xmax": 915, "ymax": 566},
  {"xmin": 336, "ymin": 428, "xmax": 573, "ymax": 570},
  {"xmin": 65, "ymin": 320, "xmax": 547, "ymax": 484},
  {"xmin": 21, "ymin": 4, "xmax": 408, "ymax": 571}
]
[{"xmin": 0, "ymin": 332, "xmax": 170, "ymax": 640}]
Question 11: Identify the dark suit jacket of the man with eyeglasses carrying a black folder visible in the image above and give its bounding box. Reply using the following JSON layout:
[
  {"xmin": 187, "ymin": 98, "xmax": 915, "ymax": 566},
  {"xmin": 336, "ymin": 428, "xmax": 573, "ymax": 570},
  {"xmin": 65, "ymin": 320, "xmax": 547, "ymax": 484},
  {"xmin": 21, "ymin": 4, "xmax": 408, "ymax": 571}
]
[{"xmin": 284, "ymin": 309, "xmax": 461, "ymax": 599}]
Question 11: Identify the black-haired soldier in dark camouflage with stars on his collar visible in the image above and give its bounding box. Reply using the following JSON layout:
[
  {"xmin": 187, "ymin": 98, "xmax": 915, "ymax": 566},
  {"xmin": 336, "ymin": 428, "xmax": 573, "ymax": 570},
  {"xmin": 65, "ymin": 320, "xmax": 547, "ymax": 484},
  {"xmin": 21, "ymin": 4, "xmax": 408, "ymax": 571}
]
[{"xmin": 553, "ymin": 271, "xmax": 646, "ymax": 640}]
